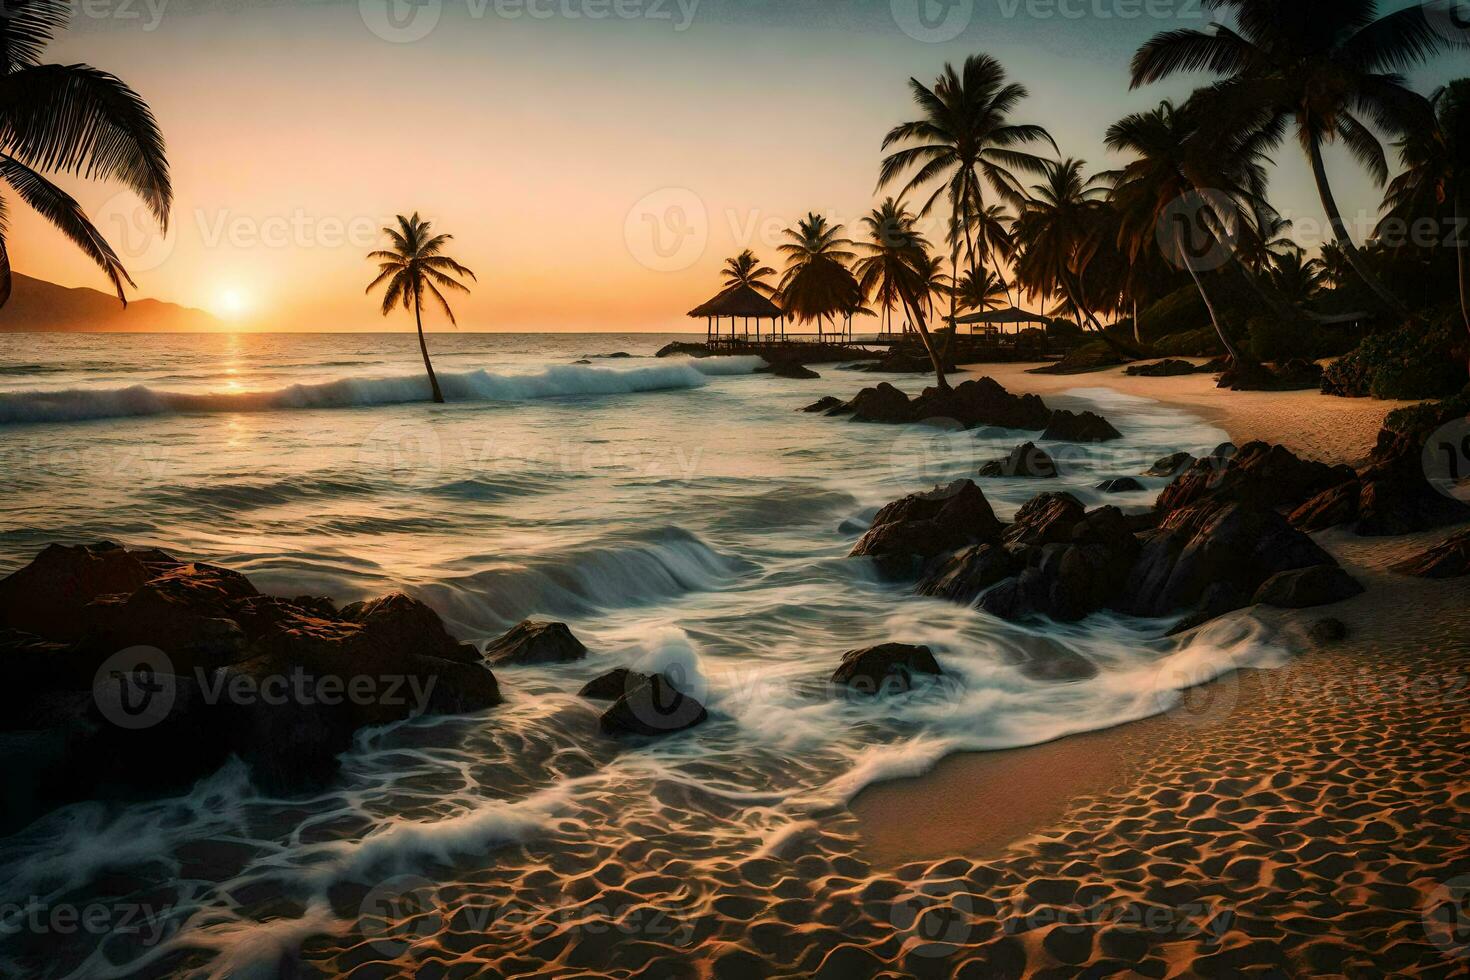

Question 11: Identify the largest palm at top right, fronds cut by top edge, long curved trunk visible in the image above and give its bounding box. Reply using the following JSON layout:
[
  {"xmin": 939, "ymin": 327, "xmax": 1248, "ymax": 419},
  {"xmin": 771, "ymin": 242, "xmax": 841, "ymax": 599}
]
[{"xmin": 1133, "ymin": 0, "xmax": 1455, "ymax": 311}]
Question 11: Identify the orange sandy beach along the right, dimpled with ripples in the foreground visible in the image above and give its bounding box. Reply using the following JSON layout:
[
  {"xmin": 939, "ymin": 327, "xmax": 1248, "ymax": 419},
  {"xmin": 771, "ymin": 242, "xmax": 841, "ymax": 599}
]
[{"xmin": 853, "ymin": 366, "xmax": 1470, "ymax": 976}]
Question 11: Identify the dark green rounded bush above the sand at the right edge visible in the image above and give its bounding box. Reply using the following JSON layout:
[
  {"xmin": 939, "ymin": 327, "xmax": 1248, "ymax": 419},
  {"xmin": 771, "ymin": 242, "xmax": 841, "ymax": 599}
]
[{"xmin": 1322, "ymin": 319, "xmax": 1466, "ymax": 398}]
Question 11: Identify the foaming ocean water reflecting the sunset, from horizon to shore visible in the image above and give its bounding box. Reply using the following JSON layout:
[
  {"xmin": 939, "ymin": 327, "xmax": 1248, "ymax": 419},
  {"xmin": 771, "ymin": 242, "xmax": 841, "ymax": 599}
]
[{"xmin": 0, "ymin": 334, "xmax": 1283, "ymax": 977}]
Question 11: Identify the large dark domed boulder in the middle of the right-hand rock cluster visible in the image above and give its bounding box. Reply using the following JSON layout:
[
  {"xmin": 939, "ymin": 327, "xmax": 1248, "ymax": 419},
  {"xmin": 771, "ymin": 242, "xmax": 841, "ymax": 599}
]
[{"xmin": 1119, "ymin": 501, "xmax": 1336, "ymax": 617}]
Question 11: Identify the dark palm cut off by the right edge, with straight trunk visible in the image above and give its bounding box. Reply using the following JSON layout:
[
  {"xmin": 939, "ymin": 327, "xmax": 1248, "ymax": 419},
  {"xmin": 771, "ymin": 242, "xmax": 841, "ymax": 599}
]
[{"xmin": 1383, "ymin": 78, "xmax": 1470, "ymax": 348}]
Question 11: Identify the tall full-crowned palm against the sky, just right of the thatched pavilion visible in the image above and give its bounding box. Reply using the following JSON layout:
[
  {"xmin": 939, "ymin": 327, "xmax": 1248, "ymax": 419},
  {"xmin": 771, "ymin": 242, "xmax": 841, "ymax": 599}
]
[{"xmin": 878, "ymin": 54, "xmax": 1057, "ymax": 351}]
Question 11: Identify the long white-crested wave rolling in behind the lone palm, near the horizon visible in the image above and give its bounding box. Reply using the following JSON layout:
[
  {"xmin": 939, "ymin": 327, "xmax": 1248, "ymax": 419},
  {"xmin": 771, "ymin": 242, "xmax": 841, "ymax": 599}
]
[{"xmin": 0, "ymin": 357, "xmax": 764, "ymax": 425}]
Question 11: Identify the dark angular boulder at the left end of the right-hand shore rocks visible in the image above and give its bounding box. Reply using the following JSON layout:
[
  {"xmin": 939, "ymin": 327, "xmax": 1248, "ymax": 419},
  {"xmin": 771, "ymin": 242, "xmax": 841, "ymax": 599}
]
[{"xmin": 851, "ymin": 480, "xmax": 1003, "ymax": 576}]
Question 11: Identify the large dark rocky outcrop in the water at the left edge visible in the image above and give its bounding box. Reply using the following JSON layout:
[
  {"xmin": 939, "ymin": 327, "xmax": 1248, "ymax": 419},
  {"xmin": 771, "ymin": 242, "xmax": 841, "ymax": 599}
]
[{"xmin": 0, "ymin": 544, "xmax": 500, "ymax": 828}]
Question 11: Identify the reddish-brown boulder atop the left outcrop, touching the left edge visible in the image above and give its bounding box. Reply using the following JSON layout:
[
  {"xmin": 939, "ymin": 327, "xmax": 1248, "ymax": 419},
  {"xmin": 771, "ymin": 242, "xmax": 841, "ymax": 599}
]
[{"xmin": 0, "ymin": 542, "xmax": 156, "ymax": 639}]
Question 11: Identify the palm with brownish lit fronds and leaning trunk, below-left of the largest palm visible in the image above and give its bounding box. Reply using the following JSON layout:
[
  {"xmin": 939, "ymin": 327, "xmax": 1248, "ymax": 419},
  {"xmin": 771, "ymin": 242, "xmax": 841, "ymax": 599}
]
[{"xmin": 1105, "ymin": 101, "xmax": 1264, "ymax": 360}]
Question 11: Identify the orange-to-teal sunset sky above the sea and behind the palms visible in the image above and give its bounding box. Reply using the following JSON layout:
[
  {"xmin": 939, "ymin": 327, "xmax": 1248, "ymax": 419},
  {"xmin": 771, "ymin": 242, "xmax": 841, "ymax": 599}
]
[{"xmin": 9, "ymin": 0, "xmax": 1470, "ymax": 331}]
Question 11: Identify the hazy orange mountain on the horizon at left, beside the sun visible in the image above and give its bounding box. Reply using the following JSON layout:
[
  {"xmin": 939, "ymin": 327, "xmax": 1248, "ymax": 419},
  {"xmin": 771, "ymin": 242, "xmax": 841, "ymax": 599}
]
[{"xmin": 0, "ymin": 273, "xmax": 223, "ymax": 334}]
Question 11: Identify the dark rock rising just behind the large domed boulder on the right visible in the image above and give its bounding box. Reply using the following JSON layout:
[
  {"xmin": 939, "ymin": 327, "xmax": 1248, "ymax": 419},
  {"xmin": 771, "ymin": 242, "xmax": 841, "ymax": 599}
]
[{"xmin": 1157, "ymin": 442, "xmax": 1354, "ymax": 514}]
